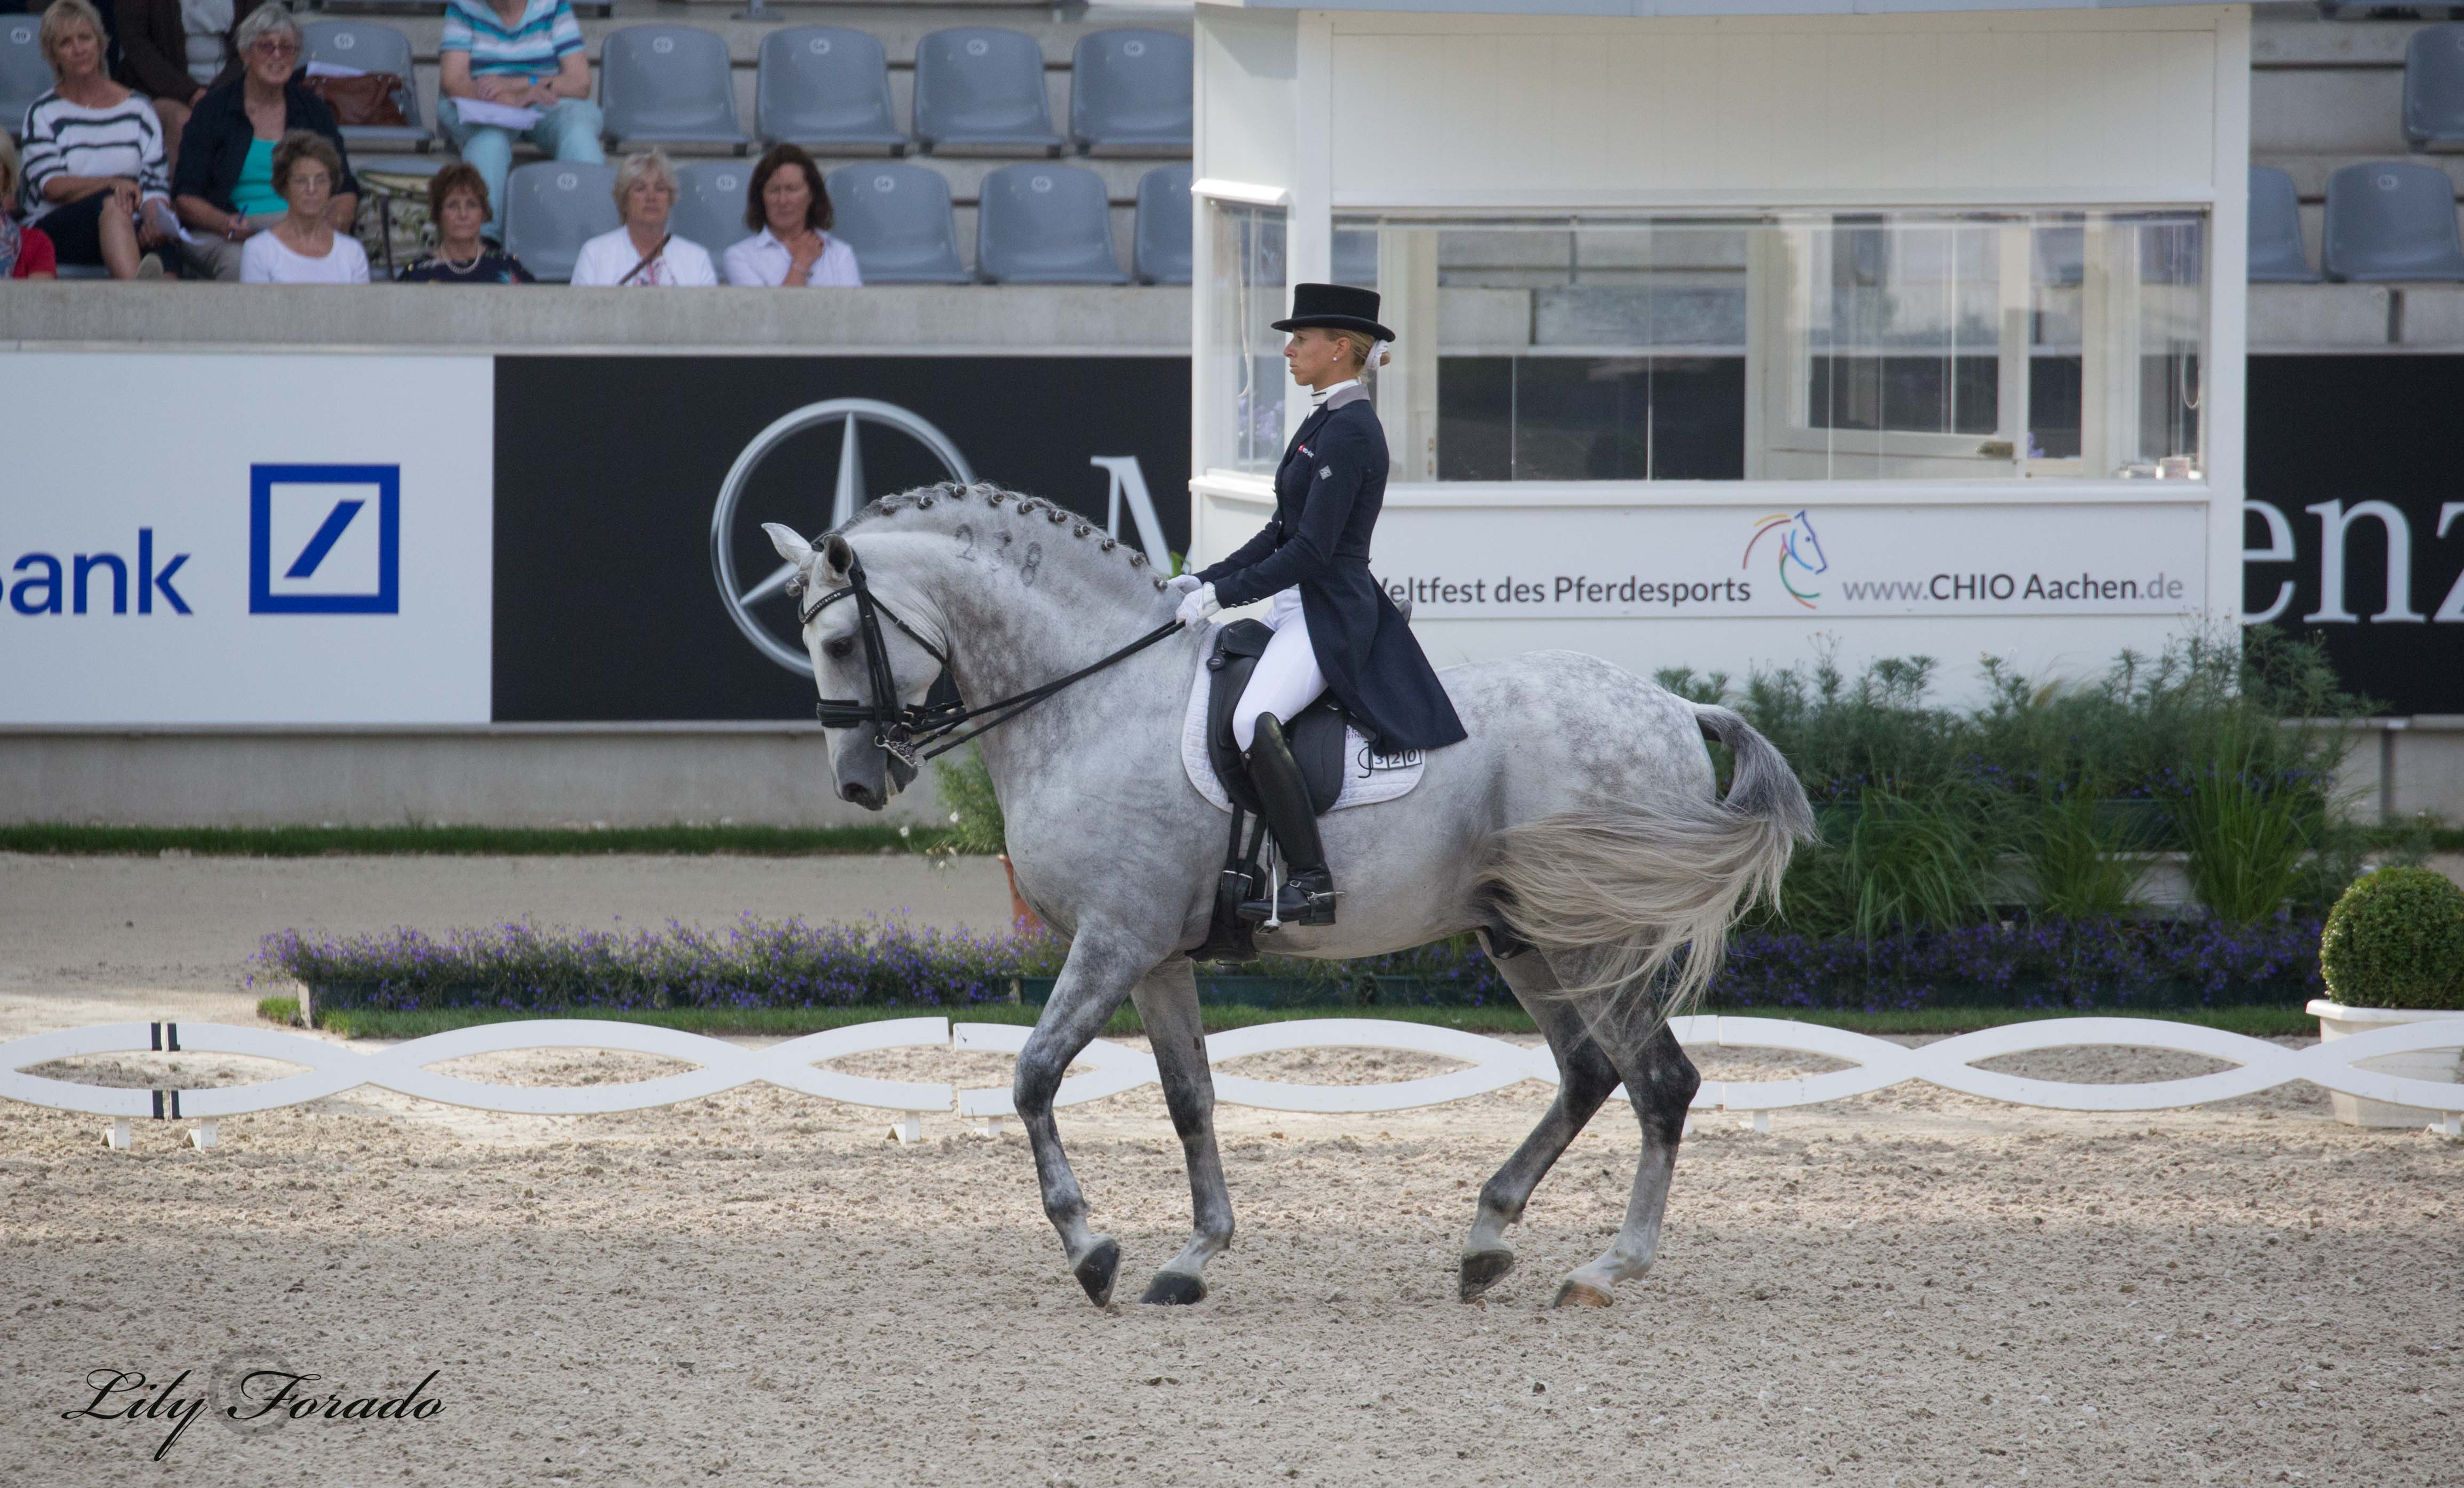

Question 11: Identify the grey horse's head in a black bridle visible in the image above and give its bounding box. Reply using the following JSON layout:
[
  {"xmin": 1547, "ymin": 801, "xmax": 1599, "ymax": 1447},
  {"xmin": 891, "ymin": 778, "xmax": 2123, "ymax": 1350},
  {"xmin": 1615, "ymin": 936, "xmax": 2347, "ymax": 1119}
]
[{"xmin": 762, "ymin": 522, "xmax": 949, "ymax": 811}]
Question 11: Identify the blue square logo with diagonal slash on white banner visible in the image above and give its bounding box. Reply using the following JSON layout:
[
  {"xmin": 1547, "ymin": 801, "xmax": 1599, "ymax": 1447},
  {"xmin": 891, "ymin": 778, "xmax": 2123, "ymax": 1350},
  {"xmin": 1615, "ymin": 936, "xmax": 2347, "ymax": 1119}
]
[{"xmin": 249, "ymin": 466, "xmax": 402, "ymax": 616}]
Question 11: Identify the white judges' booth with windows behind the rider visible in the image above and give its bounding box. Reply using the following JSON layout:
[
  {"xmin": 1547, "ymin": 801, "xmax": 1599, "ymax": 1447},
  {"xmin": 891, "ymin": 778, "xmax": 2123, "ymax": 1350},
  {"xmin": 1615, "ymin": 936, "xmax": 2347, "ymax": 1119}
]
[{"xmin": 1190, "ymin": 0, "xmax": 2250, "ymax": 685}]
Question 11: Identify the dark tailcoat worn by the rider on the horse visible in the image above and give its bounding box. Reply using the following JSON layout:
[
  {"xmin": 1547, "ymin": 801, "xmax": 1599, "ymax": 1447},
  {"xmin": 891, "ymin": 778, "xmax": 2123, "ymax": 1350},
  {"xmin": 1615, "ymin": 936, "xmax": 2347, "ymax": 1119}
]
[{"xmin": 1197, "ymin": 387, "xmax": 1463, "ymax": 751}]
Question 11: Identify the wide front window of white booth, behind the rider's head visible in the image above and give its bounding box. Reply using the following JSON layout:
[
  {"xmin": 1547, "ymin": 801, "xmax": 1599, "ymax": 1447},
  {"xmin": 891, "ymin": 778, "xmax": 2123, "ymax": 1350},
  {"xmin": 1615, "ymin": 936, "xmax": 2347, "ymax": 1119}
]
[{"xmin": 1333, "ymin": 210, "xmax": 2208, "ymax": 481}]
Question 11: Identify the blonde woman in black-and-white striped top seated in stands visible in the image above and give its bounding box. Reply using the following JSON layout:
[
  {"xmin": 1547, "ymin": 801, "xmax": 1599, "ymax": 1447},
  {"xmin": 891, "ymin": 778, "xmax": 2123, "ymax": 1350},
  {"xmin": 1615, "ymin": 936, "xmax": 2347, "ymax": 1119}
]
[{"xmin": 22, "ymin": 0, "xmax": 180, "ymax": 278}]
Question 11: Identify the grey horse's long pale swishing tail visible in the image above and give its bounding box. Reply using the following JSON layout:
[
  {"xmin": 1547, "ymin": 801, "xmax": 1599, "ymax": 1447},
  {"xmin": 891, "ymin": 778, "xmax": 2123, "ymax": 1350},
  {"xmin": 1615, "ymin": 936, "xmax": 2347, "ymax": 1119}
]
[{"xmin": 1481, "ymin": 705, "xmax": 1813, "ymax": 1018}]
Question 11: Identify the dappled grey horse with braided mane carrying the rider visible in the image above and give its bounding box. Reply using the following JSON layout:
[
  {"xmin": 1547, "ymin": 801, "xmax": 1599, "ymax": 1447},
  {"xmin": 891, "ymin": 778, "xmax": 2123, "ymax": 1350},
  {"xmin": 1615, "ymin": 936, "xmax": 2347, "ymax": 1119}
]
[{"xmin": 769, "ymin": 485, "xmax": 1813, "ymax": 1306}]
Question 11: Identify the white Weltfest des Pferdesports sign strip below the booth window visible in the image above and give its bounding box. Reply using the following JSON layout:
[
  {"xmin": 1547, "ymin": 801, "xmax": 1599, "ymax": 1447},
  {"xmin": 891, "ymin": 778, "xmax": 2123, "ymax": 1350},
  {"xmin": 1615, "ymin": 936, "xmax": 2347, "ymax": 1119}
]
[{"xmin": 1375, "ymin": 493, "xmax": 2208, "ymax": 621}]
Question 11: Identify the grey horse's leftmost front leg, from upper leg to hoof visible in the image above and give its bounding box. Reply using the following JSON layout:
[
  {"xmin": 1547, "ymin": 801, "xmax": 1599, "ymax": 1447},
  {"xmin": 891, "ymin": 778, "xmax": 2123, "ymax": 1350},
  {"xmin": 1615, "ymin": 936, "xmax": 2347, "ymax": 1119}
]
[{"xmin": 1010, "ymin": 926, "xmax": 1156, "ymax": 1306}]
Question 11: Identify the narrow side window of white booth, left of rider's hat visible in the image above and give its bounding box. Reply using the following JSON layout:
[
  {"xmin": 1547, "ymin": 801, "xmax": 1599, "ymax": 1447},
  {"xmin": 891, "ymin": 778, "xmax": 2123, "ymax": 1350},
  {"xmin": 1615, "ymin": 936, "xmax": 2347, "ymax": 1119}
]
[{"xmin": 1203, "ymin": 202, "xmax": 1291, "ymax": 470}]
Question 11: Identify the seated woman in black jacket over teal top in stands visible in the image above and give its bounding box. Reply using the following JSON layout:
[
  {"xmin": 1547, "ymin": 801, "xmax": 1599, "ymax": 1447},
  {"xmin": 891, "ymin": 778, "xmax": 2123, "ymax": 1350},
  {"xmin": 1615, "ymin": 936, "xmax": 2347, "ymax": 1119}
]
[{"xmin": 170, "ymin": 5, "xmax": 360, "ymax": 283}]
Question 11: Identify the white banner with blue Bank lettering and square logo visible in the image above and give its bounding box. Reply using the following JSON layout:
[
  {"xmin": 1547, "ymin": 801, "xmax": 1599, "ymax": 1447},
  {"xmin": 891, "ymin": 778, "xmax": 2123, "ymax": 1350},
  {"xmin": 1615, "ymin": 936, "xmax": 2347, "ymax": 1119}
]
[{"xmin": 0, "ymin": 353, "xmax": 495, "ymax": 724}]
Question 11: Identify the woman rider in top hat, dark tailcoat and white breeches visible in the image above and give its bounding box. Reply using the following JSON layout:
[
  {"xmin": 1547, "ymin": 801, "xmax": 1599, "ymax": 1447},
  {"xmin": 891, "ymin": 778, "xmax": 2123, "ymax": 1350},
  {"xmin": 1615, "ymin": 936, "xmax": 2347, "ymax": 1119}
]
[{"xmin": 1173, "ymin": 283, "xmax": 1463, "ymax": 924}]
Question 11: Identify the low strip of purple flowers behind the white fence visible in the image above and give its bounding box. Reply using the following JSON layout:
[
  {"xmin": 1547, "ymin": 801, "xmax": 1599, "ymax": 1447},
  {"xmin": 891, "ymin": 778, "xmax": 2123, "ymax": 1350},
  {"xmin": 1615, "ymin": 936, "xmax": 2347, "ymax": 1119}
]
[{"xmin": 256, "ymin": 914, "xmax": 2324, "ymax": 1012}]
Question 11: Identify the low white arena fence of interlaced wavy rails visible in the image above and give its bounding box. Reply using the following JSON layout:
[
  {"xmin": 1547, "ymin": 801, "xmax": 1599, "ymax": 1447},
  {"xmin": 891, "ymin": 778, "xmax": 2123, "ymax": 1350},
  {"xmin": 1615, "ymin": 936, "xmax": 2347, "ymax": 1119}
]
[{"xmin": 0, "ymin": 1015, "xmax": 2464, "ymax": 1148}]
